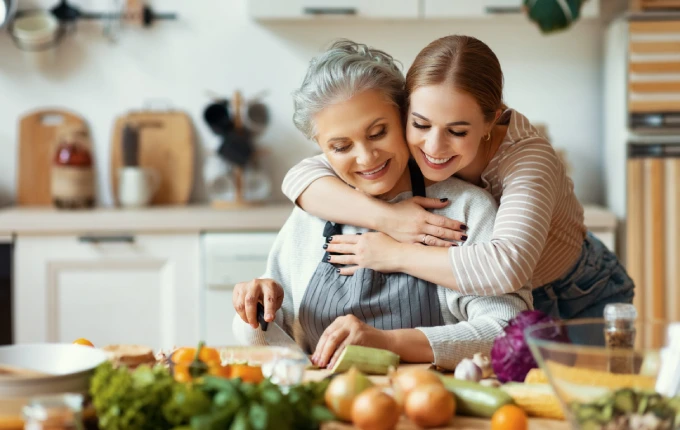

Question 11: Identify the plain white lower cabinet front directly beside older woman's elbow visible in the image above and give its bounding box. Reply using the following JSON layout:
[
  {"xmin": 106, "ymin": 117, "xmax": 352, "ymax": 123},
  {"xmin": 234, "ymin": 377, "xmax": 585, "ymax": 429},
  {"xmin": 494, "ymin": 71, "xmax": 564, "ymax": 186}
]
[{"xmin": 202, "ymin": 232, "xmax": 277, "ymax": 345}]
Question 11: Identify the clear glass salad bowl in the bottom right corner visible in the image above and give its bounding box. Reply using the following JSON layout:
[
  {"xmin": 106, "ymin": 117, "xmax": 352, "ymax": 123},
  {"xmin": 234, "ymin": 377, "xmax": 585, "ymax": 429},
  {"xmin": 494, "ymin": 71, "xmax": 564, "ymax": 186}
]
[{"xmin": 525, "ymin": 319, "xmax": 680, "ymax": 429}]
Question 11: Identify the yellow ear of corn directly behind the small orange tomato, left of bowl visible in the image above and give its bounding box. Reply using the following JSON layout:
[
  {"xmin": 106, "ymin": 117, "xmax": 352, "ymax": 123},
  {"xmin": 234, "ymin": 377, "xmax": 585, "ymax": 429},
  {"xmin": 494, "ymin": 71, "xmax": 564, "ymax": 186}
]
[{"xmin": 501, "ymin": 383, "xmax": 564, "ymax": 420}]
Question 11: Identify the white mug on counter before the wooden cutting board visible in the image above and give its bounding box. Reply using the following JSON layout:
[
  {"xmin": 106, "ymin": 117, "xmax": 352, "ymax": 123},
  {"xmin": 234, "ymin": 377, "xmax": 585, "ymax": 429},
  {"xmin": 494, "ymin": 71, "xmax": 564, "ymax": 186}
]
[{"xmin": 118, "ymin": 167, "xmax": 161, "ymax": 208}]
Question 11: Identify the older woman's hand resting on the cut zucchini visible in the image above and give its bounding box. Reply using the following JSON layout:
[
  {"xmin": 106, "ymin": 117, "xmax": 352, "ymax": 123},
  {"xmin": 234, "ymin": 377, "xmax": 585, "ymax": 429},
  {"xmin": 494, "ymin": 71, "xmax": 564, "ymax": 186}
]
[{"xmin": 312, "ymin": 315, "xmax": 390, "ymax": 368}]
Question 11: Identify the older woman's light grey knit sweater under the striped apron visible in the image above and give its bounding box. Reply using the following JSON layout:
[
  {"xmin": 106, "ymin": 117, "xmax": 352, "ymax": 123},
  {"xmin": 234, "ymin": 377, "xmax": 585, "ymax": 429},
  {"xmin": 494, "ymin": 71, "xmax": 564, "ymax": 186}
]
[{"xmin": 233, "ymin": 178, "xmax": 532, "ymax": 369}]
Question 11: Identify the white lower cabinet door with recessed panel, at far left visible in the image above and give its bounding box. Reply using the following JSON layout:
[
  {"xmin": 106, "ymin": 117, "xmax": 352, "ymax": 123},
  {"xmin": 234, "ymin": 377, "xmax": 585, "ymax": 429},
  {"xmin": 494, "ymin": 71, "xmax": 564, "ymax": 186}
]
[{"xmin": 14, "ymin": 234, "xmax": 200, "ymax": 348}]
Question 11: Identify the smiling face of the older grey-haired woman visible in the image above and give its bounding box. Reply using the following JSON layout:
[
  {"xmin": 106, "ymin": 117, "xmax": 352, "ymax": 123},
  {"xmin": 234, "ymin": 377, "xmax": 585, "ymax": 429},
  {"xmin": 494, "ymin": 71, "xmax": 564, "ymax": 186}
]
[{"xmin": 314, "ymin": 90, "xmax": 409, "ymax": 196}]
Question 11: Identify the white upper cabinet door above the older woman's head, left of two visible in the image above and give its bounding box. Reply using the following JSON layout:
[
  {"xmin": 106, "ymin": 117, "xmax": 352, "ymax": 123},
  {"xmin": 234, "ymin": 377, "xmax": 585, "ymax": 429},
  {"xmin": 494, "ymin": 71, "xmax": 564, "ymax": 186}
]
[{"xmin": 248, "ymin": 0, "xmax": 419, "ymax": 20}]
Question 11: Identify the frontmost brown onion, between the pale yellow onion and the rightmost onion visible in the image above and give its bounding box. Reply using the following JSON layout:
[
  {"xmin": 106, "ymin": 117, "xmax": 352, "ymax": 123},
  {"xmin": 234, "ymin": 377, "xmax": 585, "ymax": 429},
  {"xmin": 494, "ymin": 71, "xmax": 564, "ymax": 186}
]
[{"xmin": 352, "ymin": 387, "xmax": 401, "ymax": 430}]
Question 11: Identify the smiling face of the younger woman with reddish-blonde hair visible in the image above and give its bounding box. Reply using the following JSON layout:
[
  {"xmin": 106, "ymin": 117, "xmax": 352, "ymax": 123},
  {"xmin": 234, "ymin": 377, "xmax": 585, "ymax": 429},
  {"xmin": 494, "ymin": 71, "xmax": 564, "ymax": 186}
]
[{"xmin": 406, "ymin": 83, "xmax": 493, "ymax": 182}]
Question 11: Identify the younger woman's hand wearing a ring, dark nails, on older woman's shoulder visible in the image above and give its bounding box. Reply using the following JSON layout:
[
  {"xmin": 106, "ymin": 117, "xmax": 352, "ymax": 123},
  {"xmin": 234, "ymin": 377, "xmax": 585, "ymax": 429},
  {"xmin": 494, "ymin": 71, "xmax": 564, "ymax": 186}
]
[{"xmin": 382, "ymin": 197, "xmax": 467, "ymax": 246}]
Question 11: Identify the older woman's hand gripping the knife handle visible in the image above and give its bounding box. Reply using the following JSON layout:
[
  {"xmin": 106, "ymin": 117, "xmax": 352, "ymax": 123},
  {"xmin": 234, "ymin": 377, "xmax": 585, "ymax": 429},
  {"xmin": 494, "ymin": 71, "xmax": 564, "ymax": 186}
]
[{"xmin": 232, "ymin": 279, "xmax": 283, "ymax": 328}]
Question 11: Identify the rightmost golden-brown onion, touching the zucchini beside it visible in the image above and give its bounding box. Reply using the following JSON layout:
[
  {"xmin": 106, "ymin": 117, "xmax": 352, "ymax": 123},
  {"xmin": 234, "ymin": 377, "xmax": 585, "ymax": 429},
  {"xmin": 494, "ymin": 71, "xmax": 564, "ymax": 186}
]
[{"xmin": 404, "ymin": 384, "xmax": 456, "ymax": 428}]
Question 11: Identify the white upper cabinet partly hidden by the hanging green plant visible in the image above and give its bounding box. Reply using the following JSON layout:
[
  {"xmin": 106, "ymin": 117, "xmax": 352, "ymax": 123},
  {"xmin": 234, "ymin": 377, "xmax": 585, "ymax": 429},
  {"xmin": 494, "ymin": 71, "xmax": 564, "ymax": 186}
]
[{"xmin": 422, "ymin": 0, "xmax": 600, "ymax": 19}]
